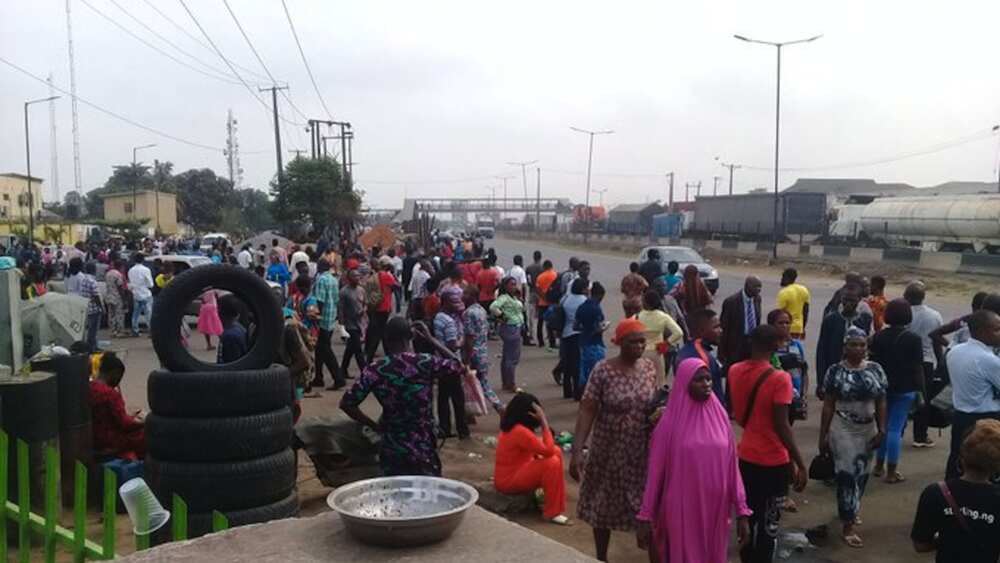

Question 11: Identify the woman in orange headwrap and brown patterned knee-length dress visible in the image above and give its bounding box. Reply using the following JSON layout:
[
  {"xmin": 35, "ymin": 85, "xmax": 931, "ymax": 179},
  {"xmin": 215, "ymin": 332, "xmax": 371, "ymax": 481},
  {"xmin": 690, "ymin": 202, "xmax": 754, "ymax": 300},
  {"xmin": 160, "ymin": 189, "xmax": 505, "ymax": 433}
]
[{"xmin": 569, "ymin": 319, "xmax": 657, "ymax": 561}]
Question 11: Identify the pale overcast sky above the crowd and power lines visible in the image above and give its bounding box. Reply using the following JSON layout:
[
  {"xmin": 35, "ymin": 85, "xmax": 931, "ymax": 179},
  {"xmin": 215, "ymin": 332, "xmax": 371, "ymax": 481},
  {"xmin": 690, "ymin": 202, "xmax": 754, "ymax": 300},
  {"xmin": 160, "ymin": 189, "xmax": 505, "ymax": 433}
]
[{"xmin": 0, "ymin": 0, "xmax": 1000, "ymax": 207}]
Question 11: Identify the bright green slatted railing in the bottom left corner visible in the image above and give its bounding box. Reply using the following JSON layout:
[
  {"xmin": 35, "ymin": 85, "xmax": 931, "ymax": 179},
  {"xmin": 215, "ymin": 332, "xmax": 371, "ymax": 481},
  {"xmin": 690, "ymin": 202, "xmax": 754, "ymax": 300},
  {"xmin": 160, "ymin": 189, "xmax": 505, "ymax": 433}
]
[{"xmin": 0, "ymin": 430, "xmax": 229, "ymax": 563}]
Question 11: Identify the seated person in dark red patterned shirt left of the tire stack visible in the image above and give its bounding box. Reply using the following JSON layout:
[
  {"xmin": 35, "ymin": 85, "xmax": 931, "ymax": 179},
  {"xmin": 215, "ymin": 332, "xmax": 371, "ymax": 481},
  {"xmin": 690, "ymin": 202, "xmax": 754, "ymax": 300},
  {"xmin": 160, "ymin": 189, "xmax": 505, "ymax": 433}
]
[{"xmin": 90, "ymin": 352, "xmax": 146, "ymax": 460}]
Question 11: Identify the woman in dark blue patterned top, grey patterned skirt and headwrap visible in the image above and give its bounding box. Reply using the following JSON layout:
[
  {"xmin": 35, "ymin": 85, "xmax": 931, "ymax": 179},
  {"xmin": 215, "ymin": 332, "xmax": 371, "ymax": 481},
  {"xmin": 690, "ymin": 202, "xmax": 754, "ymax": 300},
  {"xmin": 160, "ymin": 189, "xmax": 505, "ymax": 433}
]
[{"xmin": 819, "ymin": 327, "xmax": 889, "ymax": 548}]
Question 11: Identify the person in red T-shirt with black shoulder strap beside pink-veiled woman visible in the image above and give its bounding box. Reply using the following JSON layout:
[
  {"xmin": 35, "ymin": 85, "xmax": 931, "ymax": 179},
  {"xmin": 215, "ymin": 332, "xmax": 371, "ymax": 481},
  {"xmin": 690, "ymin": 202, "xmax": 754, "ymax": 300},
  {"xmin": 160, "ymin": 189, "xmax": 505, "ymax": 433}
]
[{"xmin": 729, "ymin": 325, "xmax": 808, "ymax": 563}]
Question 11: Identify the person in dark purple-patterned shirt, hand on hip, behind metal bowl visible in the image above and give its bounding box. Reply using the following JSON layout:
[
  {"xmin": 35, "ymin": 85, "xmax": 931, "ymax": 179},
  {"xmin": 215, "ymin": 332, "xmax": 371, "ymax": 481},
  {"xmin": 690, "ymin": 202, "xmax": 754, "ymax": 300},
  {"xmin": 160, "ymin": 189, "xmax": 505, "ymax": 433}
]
[{"xmin": 340, "ymin": 317, "xmax": 465, "ymax": 477}]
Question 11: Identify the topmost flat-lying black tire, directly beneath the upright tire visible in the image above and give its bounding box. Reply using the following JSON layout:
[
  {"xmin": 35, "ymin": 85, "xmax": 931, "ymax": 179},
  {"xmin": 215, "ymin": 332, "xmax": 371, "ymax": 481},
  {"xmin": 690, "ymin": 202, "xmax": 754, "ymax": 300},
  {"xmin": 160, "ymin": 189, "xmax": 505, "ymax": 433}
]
[{"xmin": 146, "ymin": 365, "xmax": 295, "ymax": 418}]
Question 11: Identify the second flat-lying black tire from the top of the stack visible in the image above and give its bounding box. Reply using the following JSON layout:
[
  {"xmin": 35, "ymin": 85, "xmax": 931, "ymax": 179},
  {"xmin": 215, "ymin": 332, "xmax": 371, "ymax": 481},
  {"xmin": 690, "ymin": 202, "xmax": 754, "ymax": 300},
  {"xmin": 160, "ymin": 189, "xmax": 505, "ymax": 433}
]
[{"xmin": 146, "ymin": 407, "xmax": 292, "ymax": 462}]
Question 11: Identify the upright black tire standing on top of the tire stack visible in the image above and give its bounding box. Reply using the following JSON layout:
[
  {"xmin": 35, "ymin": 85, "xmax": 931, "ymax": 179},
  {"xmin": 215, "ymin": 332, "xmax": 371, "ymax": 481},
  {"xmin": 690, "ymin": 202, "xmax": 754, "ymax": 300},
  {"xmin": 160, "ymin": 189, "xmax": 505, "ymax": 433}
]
[{"xmin": 150, "ymin": 264, "xmax": 284, "ymax": 372}]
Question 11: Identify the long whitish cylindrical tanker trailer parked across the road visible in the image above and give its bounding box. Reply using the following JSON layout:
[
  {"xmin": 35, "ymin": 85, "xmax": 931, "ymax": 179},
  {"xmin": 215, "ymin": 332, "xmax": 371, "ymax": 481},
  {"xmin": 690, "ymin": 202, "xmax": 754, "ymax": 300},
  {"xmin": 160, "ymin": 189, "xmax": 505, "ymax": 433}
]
[{"xmin": 845, "ymin": 194, "xmax": 1000, "ymax": 252}]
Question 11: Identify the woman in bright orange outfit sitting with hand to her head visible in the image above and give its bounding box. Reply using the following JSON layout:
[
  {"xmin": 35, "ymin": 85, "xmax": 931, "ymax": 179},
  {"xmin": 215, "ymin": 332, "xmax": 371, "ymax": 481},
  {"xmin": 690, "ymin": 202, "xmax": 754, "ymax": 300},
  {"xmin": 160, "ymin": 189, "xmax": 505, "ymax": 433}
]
[{"xmin": 493, "ymin": 393, "xmax": 569, "ymax": 525}]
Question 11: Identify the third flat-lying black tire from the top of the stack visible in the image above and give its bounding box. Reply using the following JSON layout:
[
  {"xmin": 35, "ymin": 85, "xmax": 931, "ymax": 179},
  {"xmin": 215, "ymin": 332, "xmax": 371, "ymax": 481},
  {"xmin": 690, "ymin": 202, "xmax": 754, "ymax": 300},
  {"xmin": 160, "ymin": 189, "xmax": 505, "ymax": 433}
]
[{"xmin": 145, "ymin": 449, "xmax": 297, "ymax": 513}]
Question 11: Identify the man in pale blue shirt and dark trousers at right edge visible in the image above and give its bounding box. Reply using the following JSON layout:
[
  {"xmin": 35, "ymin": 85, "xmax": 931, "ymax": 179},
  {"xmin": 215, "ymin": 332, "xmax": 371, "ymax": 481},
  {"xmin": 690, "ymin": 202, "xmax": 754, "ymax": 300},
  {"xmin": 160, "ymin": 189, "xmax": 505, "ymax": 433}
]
[{"xmin": 945, "ymin": 309, "xmax": 1000, "ymax": 479}]
